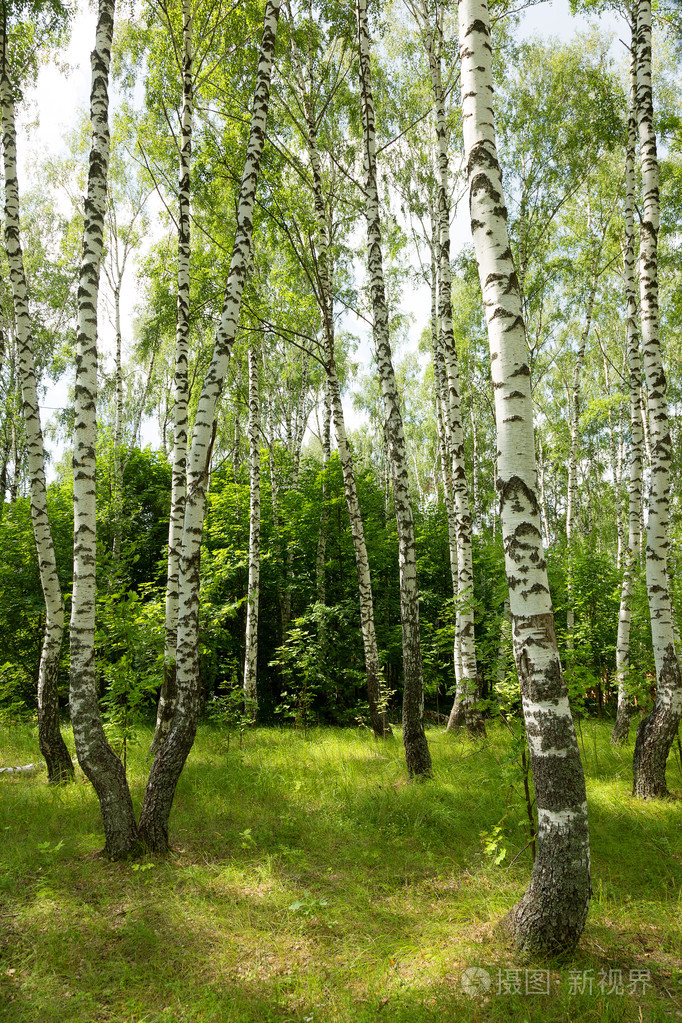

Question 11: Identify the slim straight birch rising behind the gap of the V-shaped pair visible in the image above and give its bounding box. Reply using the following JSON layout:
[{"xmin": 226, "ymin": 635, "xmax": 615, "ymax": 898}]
[{"xmin": 151, "ymin": 0, "xmax": 194, "ymax": 753}]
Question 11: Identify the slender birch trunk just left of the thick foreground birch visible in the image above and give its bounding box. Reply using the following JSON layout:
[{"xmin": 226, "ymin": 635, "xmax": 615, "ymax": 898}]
[{"xmin": 424, "ymin": 17, "xmax": 486, "ymax": 735}]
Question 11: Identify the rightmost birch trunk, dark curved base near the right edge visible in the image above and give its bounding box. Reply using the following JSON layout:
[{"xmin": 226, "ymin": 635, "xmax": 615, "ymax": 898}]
[{"xmin": 633, "ymin": 0, "xmax": 682, "ymax": 798}]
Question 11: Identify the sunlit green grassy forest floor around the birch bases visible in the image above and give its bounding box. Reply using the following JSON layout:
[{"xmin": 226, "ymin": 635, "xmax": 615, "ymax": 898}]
[{"xmin": 0, "ymin": 720, "xmax": 682, "ymax": 1023}]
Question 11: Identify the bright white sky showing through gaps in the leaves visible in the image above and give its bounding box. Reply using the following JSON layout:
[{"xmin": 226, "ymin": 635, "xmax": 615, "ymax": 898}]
[{"xmin": 18, "ymin": 0, "xmax": 623, "ymax": 473}]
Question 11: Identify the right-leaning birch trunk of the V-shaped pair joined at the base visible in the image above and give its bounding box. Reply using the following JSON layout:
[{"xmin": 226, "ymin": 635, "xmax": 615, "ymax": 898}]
[{"xmin": 140, "ymin": 0, "xmax": 280, "ymax": 852}]
